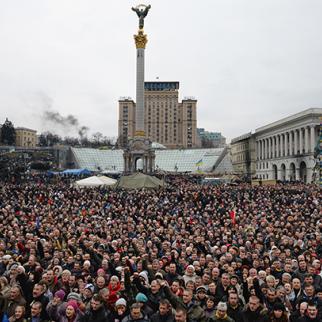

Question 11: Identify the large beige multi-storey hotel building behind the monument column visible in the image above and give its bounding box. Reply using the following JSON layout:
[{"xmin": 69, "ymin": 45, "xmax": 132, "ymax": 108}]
[{"xmin": 118, "ymin": 81, "xmax": 197, "ymax": 148}]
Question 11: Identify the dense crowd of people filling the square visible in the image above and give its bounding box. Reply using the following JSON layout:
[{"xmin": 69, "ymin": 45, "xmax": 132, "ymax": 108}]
[{"xmin": 0, "ymin": 176, "xmax": 322, "ymax": 322}]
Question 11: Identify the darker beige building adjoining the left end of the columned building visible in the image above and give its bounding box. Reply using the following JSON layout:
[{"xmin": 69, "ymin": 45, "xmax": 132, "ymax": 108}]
[{"xmin": 230, "ymin": 132, "xmax": 256, "ymax": 180}]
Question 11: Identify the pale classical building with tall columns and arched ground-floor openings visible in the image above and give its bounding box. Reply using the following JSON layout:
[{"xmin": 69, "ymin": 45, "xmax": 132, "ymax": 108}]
[{"xmin": 255, "ymin": 108, "xmax": 322, "ymax": 183}]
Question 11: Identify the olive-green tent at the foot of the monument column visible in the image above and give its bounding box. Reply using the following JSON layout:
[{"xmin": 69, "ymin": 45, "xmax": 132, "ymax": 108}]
[{"xmin": 116, "ymin": 173, "xmax": 164, "ymax": 189}]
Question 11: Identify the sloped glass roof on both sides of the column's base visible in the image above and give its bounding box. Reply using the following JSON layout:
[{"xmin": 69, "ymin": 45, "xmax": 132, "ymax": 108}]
[{"xmin": 71, "ymin": 148, "xmax": 224, "ymax": 172}]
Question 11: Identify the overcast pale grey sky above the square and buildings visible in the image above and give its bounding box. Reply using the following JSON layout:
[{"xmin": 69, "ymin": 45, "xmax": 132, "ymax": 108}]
[{"xmin": 0, "ymin": 0, "xmax": 322, "ymax": 139}]
